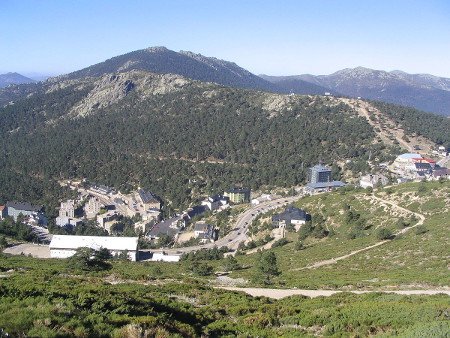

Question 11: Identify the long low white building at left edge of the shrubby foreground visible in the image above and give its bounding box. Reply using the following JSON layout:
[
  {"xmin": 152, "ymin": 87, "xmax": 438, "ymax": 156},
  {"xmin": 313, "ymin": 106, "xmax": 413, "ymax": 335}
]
[{"xmin": 50, "ymin": 235, "xmax": 138, "ymax": 261}]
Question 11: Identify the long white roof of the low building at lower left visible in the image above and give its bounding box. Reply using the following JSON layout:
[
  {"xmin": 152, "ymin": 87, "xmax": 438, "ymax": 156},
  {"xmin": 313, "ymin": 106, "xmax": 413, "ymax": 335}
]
[{"xmin": 50, "ymin": 235, "xmax": 138, "ymax": 251}]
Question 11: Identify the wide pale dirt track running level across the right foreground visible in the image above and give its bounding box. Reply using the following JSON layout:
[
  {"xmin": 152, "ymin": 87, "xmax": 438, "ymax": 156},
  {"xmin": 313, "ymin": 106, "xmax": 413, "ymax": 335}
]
[{"xmin": 217, "ymin": 286, "xmax": 450, "ymax": 299}]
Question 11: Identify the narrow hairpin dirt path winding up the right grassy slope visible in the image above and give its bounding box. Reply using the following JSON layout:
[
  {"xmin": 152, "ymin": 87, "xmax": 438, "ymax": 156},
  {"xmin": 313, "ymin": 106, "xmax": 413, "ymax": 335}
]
[{"xmin": 293, "ymin": 195, "xmax": 425, "ymax": 271}]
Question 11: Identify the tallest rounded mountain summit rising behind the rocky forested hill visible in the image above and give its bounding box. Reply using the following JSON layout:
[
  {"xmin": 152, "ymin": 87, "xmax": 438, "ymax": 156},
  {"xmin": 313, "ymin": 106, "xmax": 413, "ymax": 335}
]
[{"xmin": 56, "ymin": 47, "xmax": 326, "ymax": 95}]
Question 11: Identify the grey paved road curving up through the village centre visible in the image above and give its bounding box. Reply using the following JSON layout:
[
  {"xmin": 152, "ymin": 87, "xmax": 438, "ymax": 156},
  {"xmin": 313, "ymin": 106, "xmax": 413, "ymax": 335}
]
[{"xmin": 145, "ymin": 195, "xmax": 302, "ymax": 254}]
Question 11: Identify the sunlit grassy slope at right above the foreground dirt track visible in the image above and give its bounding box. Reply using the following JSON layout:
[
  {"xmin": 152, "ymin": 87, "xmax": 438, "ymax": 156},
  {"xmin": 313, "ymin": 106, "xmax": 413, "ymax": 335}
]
[{"xmin": 233, "ymin": 182, "xmax": 450, "ymax": 288}]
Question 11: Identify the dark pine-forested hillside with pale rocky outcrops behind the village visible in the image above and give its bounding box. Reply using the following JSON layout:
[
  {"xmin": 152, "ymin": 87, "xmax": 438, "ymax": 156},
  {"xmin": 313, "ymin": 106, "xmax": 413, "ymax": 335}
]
[{"xmin": 0, "ymin": 71, "xmax": 406, "ymax": 213}]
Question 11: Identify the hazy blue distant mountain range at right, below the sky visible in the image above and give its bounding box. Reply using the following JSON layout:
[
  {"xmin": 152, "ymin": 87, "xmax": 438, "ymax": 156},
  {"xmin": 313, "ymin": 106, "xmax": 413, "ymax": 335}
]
[{"xmin": 265, "ymin": 67, "xmax": 450, "ymax": 116}]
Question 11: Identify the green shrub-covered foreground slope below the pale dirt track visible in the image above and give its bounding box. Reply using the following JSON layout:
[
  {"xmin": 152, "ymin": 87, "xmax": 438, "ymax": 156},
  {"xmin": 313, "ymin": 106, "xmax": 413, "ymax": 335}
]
[{"xmin": 0, "ymin": 256, "xmax": 450, "ymax": 337}]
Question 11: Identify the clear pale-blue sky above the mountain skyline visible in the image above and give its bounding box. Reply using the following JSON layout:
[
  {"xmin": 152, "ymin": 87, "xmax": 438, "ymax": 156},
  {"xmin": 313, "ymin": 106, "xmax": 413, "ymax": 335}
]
[{"xmin": 0, "ymin": 0, "xmax": 450, "ymax": 77}]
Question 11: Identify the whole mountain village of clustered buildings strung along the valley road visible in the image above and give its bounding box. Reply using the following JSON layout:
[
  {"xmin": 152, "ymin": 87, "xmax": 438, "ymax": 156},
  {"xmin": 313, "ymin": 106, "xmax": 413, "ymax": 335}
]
[{"xmin": 0, "ymin": 146, "xmax": 450, "ymax": 262}]
